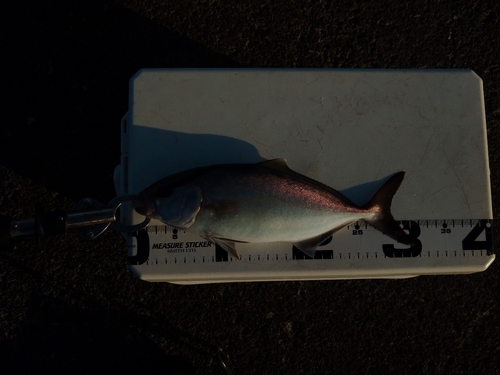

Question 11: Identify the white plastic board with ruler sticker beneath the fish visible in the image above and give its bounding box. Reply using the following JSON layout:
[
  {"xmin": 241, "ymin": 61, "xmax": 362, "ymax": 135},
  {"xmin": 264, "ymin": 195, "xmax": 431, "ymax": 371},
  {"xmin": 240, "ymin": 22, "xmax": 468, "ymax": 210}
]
[{"xmin": 115, "ymin": 69, "xmax": 495, "ymax": 284}]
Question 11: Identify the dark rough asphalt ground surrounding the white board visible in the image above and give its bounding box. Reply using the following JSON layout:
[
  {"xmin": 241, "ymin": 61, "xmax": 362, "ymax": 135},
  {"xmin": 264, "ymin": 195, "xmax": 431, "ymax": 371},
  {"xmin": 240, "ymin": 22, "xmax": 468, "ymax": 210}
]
[{"xmin": 0, "ymin": 0, "xmax": 500, "ymax": 374}]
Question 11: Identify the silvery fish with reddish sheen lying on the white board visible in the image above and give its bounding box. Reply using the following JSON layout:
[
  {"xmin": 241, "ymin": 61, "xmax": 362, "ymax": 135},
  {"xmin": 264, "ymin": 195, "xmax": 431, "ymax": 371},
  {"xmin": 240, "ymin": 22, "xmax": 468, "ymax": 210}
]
[{"xmin": 135, "ymin": 159, "xmax": 413, "ymax": 259}]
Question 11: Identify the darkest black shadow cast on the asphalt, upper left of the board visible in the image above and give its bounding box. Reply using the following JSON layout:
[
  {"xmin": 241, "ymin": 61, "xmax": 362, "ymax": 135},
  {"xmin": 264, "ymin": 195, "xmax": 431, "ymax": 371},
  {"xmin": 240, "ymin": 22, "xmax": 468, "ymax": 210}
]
[{"xmin": 0, "ymin": 0, "xmax": 238, "ymax": 201}]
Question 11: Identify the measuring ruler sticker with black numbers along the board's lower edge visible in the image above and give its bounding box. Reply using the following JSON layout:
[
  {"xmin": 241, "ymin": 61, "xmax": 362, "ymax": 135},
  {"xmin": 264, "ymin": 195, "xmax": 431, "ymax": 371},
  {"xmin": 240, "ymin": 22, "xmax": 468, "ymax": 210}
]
[{"xmin": 124, "ymin": 219, "xmax": 494, "ymax": 283}]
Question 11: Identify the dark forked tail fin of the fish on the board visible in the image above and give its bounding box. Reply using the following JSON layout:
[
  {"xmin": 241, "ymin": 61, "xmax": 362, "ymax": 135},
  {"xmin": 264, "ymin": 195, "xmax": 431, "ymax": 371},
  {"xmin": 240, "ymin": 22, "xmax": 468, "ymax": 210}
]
[{"xmin": 363, "ymin": 172, "xmax": 415, "ymax": 245}]
